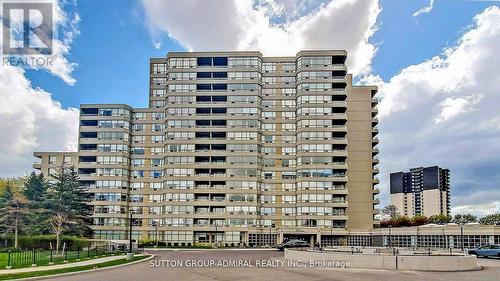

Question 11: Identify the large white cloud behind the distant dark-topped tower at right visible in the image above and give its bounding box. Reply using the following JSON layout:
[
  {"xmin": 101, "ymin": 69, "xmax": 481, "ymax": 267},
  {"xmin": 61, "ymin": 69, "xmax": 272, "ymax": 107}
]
[{"xmin": 374, "ymin": 6, "xmax": 500, "ymax": 212}]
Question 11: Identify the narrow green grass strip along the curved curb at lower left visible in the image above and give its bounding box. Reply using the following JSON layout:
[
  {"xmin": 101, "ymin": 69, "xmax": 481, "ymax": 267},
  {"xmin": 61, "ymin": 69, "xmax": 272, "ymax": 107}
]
[{"xmin": 0, "ymin": 255, "xmax": 149, "ymax": 280}]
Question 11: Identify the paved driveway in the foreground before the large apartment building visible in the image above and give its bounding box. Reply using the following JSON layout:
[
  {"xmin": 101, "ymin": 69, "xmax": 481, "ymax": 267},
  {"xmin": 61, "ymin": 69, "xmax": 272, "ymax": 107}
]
[{"xmin": 44, "ymin": 250, "xmax": 500, "ymax": 281}]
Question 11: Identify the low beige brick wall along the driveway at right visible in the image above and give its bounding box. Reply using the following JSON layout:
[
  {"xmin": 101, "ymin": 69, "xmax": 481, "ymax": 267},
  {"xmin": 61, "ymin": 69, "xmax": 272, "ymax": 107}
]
[{"xmin": 285, "ymin": 249, "xmax": 478, "ymax": 271}]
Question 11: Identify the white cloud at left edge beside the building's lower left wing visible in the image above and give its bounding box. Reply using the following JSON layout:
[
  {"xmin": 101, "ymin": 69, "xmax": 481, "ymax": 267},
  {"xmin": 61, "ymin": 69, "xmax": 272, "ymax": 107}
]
[{"xmin": 0, "ymin": 65, "xmax": 78, "ymax": 176}]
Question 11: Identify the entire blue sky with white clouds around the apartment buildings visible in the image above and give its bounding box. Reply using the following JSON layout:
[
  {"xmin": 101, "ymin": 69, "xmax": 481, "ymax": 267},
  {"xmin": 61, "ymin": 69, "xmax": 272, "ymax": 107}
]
[{"xmin": 0, "ymin": 0, "xmax": 500, "ymax": 214}]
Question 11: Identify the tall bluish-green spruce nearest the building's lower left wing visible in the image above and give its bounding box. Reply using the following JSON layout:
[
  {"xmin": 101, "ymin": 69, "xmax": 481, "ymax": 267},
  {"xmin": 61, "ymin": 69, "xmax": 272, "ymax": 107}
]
[{"xmin": 47, "ymin": 167, "xmax": 92, "ymax": 251}]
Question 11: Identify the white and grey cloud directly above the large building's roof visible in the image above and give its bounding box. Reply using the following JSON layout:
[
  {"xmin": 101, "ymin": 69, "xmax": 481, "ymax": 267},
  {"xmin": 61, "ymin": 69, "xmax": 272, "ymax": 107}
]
[{"xmin": 143, "ymin": 0, "xmax": 380, "ymax": 74}]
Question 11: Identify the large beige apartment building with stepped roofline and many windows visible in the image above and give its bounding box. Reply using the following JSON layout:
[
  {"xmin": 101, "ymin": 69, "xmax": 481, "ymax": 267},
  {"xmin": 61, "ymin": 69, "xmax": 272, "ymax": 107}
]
[{"xmin": 34, "ymin": 50, "xmax": 378, "ymax": 246}]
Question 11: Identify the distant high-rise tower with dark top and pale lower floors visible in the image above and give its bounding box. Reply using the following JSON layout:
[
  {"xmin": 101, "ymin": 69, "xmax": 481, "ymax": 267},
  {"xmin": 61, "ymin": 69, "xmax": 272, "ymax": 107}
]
[{"xmin": 390, "ymin": 166, "xmax": 450, "ymax": 216}]
